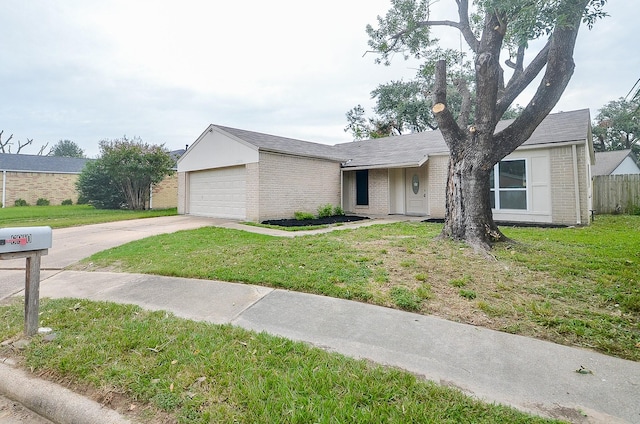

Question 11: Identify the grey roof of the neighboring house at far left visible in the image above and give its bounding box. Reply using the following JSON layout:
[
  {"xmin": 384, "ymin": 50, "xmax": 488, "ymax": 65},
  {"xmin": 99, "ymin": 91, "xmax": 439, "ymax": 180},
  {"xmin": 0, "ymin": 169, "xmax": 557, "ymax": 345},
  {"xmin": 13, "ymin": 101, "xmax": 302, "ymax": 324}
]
[{"xmin": 0, "ymin": 153, "xmax": 92, "ymax": 174}]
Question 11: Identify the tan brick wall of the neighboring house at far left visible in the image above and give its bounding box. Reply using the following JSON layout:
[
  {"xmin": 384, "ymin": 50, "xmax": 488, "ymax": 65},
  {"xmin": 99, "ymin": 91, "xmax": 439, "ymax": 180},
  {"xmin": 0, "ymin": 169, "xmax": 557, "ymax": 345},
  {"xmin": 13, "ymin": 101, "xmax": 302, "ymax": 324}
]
[{"xmin": 0, "ymin": 171, "xmax": 78, "ymax": 207}]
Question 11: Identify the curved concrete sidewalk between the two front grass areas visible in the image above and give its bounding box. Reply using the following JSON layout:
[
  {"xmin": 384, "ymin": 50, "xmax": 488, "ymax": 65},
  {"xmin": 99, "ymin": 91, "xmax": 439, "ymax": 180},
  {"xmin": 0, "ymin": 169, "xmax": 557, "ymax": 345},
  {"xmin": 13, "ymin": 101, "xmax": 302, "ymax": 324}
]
[{"xmin": 12, "ymin": 271, "xmax": 640, "ymax": 423}]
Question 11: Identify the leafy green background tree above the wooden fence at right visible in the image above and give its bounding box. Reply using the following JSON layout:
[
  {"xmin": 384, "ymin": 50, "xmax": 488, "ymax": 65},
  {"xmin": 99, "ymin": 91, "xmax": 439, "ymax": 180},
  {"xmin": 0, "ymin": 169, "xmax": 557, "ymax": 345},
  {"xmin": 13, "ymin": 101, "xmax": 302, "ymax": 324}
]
[{"xmin": 593, "ymin": 97, "xmax": 640, "ymax": 155}]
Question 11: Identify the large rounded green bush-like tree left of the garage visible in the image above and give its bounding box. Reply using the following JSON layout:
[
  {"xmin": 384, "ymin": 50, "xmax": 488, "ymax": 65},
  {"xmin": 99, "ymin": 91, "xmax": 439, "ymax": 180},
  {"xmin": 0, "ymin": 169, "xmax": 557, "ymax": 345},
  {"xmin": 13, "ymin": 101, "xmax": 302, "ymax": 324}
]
[{"xmin": 77, "ymin": 137, "xmax": 174, "ymax": 210}]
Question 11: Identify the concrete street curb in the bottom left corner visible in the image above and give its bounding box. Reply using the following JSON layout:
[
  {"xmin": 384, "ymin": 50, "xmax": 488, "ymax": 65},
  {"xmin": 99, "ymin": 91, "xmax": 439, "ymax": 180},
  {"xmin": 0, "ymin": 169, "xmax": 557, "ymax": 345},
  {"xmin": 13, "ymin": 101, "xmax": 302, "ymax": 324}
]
[{"xmin": 0, "ymin": 358, "xmax": 132, "ymax": 424}]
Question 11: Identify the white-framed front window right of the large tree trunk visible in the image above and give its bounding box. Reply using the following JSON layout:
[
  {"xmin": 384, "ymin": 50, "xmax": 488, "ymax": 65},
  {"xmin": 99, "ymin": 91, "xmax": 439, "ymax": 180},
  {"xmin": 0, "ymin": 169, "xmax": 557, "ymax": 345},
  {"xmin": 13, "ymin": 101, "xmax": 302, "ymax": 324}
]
[{"xmin": 490, "ymin": 159, "xmax": 527, "ymax": 210}]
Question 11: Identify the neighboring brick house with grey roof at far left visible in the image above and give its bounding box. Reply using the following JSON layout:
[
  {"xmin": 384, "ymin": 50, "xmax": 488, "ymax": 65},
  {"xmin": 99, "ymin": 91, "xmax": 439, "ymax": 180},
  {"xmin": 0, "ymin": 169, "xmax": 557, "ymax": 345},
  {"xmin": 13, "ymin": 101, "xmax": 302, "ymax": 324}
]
[{"xmin": 0, "ymin": 153, "xmax": 89, "ymax": 207}]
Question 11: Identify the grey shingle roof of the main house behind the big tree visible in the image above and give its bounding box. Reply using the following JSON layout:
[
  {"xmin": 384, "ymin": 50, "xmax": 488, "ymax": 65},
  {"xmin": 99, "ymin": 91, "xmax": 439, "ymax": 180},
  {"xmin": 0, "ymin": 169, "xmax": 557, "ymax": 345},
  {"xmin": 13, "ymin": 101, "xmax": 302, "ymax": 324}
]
[{"xmin": 192, "ymin": 109, "xmax": 591, "ymax": 168}]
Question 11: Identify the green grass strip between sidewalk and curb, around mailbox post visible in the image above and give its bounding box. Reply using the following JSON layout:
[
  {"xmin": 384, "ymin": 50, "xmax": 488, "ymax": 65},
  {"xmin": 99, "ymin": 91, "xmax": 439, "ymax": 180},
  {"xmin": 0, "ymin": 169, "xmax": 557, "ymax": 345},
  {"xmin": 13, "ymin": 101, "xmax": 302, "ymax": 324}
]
[{"xmin": 0, "ymin": 299, "xmax": 551, "ymax": 423}]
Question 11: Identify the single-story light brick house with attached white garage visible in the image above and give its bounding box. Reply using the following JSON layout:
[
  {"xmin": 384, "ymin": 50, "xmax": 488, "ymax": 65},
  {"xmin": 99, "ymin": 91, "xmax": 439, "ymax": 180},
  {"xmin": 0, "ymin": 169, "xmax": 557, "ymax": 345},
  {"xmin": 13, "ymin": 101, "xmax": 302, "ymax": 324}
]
[{"xmin": 178, "ymin": 109, "xmax": 594, "ymax": 225}]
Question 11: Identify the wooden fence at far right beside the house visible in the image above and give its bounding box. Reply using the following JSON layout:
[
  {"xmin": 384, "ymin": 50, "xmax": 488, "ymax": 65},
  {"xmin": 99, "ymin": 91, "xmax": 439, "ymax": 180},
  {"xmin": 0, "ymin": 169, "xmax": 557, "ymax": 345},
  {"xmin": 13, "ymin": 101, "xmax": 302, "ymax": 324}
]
[{"xmin": 593, "ymin": 174, "xmax": 640, "ymax": 214}]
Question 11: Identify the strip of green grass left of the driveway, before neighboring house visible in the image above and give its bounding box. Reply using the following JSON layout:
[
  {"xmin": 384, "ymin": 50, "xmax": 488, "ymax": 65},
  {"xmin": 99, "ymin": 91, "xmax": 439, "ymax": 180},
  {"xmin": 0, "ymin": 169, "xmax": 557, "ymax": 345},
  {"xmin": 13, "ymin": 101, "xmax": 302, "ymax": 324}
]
[{"xmin": 0, "ymin": 205, "xmax": 176, "ymax": 228}]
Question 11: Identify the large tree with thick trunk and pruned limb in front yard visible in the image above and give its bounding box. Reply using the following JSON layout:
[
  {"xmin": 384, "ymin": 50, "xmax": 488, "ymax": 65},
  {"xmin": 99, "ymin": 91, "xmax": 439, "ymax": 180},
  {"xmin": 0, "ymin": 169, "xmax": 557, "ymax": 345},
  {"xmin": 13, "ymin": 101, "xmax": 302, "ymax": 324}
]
[{"xmin": 367, "ymin": 0, "xmax": 606, "ymax": 250}]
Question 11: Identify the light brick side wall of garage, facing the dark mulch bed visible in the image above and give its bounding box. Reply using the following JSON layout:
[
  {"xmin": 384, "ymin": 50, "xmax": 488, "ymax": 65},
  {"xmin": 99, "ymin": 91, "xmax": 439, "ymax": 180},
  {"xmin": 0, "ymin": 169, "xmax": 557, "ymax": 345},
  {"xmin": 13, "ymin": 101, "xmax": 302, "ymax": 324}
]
[{"xmin": 258, "ymin": 152, "xmax": 340, "ymax": 221}]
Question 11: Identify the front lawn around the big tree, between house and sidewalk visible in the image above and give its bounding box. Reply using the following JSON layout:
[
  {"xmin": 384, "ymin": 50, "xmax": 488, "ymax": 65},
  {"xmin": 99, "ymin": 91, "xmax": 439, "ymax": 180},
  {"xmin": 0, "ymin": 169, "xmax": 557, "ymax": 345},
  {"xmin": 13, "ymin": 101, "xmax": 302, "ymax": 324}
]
[{"xmin": 80, "ymin": 215, "xmax": 640, "ymax": 361}]
